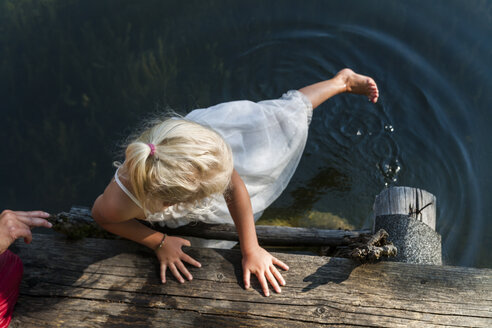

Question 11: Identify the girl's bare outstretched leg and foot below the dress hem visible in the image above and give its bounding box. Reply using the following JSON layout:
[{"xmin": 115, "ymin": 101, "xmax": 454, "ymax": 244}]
[{"xmin": 299, "ymin": 68, "xmax": 379, "ymax": 108}]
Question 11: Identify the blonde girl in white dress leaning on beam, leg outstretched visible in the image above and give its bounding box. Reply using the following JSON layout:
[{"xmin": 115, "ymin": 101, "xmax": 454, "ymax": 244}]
[{"xmin": 92, "ymin": 69, "xmax": 379, "ymax": 296}]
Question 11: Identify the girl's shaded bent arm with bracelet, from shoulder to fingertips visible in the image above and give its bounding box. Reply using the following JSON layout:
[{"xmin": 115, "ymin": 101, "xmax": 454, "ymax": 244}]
[{"xmin": 92, "ymin": 191, "xmax": 201, "ymax": 283}]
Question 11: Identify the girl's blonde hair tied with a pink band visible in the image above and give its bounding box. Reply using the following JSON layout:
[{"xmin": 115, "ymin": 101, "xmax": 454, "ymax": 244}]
[{"xmin": 120, "ymin": 118, "xmax": 234, "ymax": 214}]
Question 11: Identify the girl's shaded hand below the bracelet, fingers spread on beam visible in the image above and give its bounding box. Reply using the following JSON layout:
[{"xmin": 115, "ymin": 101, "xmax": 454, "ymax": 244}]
[{"xmin": 155, "ymin": 236, "xmax": 202, "ymax": 284}]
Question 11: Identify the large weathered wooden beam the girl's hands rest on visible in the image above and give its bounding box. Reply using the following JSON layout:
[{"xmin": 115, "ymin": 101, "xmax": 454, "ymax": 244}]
[{"xmin": 13, "ymin": 234, "xmax": 492, "ymax": 327}]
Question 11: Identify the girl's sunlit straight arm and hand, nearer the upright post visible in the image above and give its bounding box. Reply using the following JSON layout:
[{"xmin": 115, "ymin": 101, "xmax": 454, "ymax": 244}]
[{"xmin": 225, "ymin": 170, "xmax": 289, "ymax": 296}]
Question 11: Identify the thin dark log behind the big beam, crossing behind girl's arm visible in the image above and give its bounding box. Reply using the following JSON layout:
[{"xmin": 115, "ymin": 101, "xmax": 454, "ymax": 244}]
[{"xmin": 50, "ymin": 207, "xmax": 370, "ymax": 247}]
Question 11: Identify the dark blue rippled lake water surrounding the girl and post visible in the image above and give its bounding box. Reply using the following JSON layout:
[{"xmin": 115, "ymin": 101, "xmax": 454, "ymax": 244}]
[{"xmin": 0, "ymin": 0, "xmax": 492, "ymax": 267}]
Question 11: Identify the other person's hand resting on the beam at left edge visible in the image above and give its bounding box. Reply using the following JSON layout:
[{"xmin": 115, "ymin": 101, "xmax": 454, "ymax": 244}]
[{"xmin": 0, "ymin": 210, "xmax": 51, "ymax": 254}]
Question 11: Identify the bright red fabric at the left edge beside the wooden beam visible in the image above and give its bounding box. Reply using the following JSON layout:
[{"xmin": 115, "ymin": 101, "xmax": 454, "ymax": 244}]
[{"xmin": 0, "ymin": 250, "xmax": 24, "ymax": 328}]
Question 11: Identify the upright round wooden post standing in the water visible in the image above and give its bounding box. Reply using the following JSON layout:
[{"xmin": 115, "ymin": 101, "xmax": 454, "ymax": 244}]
[{"xmin": 373, "ymin": 187, "xmax": 442, "ymax": 265}]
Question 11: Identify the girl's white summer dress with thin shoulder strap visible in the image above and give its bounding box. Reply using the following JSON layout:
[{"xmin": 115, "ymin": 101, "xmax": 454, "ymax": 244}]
[{"xmin": 115, "ymin": 90, "xmax": 313, "ymax": 248}]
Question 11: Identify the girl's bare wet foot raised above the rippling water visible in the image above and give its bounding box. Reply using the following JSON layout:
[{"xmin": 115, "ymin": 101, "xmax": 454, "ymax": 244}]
[{"xmin": 335, "ymin": 68, "xmax": 379, "ymax": 103}]
